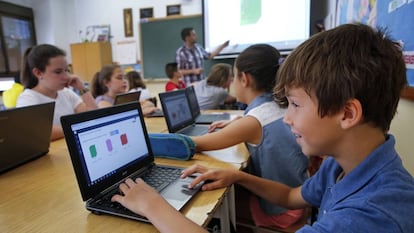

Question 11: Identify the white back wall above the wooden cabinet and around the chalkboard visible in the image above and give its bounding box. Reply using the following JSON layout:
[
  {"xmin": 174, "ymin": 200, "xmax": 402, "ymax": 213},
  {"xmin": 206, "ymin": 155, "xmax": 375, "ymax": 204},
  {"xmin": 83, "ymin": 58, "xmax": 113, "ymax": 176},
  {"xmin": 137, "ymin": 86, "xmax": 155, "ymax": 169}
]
[{"xmin": 2, "ymin": 0, "xmax": 202, "ymax": 63}]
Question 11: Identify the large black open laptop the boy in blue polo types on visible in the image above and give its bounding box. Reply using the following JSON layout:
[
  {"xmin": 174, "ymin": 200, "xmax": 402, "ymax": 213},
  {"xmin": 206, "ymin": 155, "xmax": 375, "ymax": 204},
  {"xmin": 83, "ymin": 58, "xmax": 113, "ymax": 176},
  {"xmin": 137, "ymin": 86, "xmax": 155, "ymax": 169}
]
[{"xmin": 61, "ymin": 102, "xmax": 201, "ymax": 222}]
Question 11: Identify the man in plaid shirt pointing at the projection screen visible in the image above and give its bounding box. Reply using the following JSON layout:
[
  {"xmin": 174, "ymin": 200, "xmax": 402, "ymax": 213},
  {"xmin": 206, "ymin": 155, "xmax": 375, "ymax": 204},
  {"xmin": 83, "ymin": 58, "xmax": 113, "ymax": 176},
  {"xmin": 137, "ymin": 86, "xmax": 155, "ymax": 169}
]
[{"xmin": 175, "ymin": 27, "xmax": 229, "ymax": 86}]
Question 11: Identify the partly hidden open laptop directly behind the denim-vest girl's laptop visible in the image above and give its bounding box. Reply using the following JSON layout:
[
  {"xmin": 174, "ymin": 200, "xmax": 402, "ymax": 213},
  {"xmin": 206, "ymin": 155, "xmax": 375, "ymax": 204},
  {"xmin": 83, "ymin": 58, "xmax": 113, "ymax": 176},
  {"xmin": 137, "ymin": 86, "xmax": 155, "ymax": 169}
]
[{"xmin": 186, "ymin": 86, "xmax": 230, "ymax": 124}]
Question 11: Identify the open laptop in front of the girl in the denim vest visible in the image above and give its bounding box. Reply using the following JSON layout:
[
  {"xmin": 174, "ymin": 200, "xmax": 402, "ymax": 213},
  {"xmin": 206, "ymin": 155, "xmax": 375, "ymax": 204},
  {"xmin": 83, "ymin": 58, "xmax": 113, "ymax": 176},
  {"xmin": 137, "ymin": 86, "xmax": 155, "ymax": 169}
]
[{"xmin": 158, "ymin": 89, "xmax": 208, "ymax": 136}]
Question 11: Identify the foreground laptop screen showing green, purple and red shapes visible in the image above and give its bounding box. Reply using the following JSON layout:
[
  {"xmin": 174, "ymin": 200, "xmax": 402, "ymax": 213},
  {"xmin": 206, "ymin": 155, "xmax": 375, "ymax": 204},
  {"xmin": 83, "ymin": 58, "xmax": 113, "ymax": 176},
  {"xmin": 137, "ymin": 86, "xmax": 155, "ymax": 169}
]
[{"xmin": 72, "ymin": 110, "xmax": 148, "ymax": 186}]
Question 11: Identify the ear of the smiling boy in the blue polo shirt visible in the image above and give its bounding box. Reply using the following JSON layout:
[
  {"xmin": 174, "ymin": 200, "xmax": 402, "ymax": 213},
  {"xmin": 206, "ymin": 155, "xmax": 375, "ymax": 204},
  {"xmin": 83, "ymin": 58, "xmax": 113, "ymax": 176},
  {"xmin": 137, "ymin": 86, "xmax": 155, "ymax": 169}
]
[{"xmin": 341, "ymin": 99, "xmax": 363, "ymax": 129}]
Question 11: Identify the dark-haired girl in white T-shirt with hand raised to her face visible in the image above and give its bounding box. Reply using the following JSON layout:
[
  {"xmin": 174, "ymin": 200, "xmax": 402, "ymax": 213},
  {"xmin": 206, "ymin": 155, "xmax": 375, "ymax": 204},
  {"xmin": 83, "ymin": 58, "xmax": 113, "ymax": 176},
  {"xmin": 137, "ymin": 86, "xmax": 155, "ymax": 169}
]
[{"xmin": 16, "ymin": 44, "xmax": 97, "ymax": 140}]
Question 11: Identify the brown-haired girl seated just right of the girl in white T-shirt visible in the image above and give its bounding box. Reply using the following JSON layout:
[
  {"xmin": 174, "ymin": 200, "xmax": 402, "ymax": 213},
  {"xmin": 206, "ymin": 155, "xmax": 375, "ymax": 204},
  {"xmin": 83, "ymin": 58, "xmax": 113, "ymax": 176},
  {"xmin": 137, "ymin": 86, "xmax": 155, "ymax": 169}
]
[{"xmin": 91, "ymin": 65, "xmax": 157, "ymax": 115}]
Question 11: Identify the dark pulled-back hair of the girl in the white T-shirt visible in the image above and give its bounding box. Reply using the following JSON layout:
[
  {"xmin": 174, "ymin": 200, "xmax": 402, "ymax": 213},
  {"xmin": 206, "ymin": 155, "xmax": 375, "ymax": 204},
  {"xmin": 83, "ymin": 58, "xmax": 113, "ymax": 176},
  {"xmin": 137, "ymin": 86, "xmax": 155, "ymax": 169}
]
[{"xmin": 20, "ymin": 44, "xmax": 66, "ymax": 89}]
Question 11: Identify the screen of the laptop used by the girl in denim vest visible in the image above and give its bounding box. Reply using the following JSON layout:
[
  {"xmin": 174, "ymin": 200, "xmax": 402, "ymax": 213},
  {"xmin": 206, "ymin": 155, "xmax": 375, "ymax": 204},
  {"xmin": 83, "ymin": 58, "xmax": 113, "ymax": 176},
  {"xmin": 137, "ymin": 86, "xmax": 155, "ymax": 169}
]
[{"xmin": 160, "ymin": 90, "xmax": 194, "ymax": 132}]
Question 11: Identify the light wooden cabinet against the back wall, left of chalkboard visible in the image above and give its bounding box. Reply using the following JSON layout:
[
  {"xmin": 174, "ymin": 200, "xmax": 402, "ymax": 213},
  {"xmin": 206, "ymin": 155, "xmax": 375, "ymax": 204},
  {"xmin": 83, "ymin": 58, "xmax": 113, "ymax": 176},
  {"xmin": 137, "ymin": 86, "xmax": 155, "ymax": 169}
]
[{"xmin": 70, "ymin": 42, "xmax": 112, "ymax": 82}]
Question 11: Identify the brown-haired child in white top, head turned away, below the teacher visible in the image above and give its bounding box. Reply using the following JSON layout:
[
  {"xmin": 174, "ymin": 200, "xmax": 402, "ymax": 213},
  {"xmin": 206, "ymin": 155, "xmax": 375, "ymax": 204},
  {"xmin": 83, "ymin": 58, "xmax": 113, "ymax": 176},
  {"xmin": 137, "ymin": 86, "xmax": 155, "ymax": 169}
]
[{"xmin": 194, "ymin": 63, "xmax": 236, "ymax": 110}]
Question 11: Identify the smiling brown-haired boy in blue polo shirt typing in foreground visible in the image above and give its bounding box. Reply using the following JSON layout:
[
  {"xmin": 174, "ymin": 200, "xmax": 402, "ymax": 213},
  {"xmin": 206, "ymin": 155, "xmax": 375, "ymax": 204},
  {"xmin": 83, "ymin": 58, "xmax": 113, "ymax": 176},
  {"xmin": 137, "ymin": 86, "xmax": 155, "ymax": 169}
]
[{"xmin": 112, "ymin": 24, "xmax": 414, "ymax": 232}]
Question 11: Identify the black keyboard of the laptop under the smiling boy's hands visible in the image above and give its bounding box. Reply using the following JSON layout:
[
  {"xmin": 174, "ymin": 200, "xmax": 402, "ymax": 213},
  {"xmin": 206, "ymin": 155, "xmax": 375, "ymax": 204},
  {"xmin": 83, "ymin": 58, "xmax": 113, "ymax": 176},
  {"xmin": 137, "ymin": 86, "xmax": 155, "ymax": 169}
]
[{"xmin": 90, "ymin": 166, "xmax": 182, "ymax": 219}]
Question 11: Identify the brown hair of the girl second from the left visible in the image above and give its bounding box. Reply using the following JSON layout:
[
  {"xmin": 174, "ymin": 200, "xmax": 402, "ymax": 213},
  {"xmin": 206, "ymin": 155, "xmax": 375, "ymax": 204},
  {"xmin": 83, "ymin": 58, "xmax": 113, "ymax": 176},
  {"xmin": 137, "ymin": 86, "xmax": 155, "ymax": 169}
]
[{"xmin": 91, "ymin": 64, "xmax": 120, "ymax": 98}]
